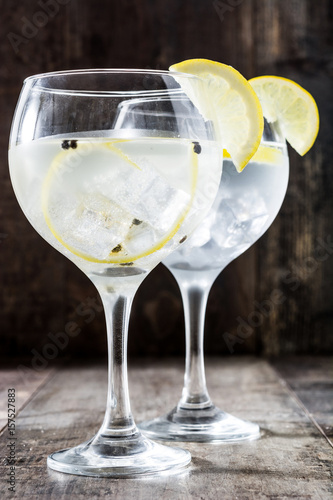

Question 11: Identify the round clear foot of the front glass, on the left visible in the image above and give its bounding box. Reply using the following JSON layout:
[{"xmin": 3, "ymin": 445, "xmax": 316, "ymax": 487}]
[{"xmin": 47, "ymin": 433, "xmax": 191, "ymax": 477}]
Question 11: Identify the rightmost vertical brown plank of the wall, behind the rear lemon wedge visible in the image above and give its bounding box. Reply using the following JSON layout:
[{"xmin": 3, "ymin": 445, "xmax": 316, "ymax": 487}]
[{"xmin": 255, "ymin": 0, "xmax": 333, "ymax": 356}]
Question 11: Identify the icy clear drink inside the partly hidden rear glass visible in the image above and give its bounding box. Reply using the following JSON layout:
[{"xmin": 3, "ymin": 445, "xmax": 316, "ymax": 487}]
[{"xmin": 163, "ymin": 143, "xmax": 289, "ymax": 271}]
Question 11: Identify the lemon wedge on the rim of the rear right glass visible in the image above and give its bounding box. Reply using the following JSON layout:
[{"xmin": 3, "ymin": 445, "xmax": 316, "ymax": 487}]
[{"xmin": 249, "ymin": 76, "xmax": 319, "ymax": 156}]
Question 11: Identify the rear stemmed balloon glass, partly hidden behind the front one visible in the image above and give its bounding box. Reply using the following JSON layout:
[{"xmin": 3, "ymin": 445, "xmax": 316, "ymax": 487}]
[{"xmin": 139, "ymin": 120, "xmax": 289, "ymax": 442}]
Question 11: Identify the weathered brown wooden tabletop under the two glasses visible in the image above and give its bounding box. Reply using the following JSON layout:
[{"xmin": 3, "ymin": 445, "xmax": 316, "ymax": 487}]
[{"xmin": 0, "ymin": 356, "xmax": 333, "ymax": 500}]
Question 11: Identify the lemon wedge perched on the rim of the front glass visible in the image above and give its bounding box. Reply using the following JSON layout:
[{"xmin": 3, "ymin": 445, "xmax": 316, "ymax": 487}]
[{"xmin": 169, "ymin": 59, "xmax": 264, "ymax": 172}]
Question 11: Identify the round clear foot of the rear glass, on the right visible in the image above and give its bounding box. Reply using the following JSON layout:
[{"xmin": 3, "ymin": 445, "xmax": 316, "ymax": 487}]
[{"xmin": 138, "ymin": 404, "xmax": 260, "ymax": 443}]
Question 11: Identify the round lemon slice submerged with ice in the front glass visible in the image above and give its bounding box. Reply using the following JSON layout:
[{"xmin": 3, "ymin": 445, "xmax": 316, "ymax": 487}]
[{"xmin": 42, "ymin": 138, "xmax": 198, "ymax": 265}]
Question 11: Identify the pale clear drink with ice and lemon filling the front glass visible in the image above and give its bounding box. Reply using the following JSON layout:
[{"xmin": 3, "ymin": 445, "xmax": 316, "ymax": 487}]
[{"xmin": 9, "ymin": 136, "xmax": 222, "ymax": 268}]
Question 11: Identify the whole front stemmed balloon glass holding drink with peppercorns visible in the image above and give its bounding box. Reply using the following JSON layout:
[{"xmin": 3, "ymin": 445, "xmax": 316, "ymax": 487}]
[{"xmin": 9, "ymin": 70, "xmax": 222, "ymax": 476}]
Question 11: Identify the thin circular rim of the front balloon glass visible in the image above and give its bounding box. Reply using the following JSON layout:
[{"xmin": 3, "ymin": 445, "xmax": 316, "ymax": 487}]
[{"xmin": 23, "ymin": 68, "xmax": 202, "ymax": 96}]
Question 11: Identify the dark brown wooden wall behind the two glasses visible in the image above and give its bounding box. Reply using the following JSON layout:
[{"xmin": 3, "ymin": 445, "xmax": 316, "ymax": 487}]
[{"xmin": 0, "ymin": 0, "xmax": 333, "ymax": 360}]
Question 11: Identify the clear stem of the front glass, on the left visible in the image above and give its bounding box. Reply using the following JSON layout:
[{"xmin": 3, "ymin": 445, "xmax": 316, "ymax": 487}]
[{"xmin": 94, "ymin": 287, "xmax": 138, "ymax": 437}]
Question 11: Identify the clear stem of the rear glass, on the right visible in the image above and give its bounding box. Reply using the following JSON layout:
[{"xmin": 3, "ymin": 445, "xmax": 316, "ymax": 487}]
[{"xmin": 178, "ymin": 274, "xmax": 216, "ymax": 409}]
